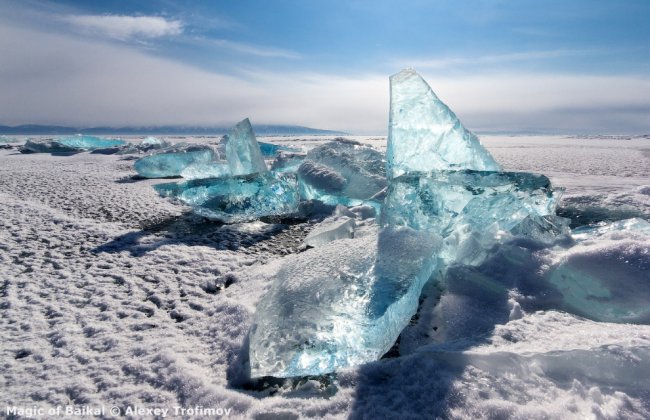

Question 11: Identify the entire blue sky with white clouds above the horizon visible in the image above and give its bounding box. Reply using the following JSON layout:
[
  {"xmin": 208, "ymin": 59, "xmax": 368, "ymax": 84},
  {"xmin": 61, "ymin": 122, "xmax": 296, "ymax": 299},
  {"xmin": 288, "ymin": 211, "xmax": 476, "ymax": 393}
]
[{"xmin": 0, "ymin": 0, "xmax": 650, "ymax": 134}]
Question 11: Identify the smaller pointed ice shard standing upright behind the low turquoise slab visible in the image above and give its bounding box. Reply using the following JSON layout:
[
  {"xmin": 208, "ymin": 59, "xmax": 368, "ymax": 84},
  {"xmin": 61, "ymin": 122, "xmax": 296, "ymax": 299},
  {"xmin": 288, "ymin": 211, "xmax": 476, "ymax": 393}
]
[{"xmin": 226, "ymin": 118, "xmax": 268, "ymax": 175}]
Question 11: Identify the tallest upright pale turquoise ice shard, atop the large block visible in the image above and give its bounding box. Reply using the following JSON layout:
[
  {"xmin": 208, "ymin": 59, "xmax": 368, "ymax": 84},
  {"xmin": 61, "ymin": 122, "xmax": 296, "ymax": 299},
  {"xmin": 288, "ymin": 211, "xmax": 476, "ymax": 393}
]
[{"xmin": 386, "ymin": 69, "xmax": 501, "ymax": 178}]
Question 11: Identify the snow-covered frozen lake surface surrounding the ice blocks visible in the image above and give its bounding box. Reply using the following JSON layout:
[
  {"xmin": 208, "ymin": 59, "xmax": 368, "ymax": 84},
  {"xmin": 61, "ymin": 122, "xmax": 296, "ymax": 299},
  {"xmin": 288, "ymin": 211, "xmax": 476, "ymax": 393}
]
[{"xmin": 0, "ymin": 136, "xmax": 650, "ymax": 419}]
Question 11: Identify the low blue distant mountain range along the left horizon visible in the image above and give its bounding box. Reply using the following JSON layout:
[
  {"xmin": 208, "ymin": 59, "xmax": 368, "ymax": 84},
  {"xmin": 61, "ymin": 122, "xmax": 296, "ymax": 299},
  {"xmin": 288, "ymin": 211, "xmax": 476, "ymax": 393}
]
[{"xmin": 0, "ymin": 124, "xmax": 348, "ymax": 136}]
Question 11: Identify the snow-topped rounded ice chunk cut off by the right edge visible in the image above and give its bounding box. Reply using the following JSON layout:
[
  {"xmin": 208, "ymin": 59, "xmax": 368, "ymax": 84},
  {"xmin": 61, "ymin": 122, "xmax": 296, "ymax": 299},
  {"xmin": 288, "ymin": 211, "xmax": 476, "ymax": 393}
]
[{"xmin": 545, "ymin": 219, "xmax": 650, "ymax": 324}]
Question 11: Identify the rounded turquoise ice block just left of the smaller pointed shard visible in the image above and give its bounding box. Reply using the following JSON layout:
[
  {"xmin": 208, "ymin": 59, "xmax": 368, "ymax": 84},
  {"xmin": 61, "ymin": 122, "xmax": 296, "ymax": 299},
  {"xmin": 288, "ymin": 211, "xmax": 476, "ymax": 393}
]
[{"xmin": 133, "ymin": 144, "xmax": 216, "ymax": 178}]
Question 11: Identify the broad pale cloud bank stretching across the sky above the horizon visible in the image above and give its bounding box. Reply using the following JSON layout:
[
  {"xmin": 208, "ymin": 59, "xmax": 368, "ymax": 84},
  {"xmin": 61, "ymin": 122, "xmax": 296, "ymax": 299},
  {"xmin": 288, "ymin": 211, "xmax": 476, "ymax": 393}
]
[{"xmin": 0, "ymin": 24, "xmax": 650, "ymax": 134}]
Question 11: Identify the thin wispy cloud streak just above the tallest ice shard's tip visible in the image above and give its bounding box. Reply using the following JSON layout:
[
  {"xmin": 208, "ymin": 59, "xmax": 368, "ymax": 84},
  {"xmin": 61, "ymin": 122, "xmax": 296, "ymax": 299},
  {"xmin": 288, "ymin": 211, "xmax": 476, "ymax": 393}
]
[{"xmin": 394, "ymin": 49, "xmax": 594, "ymax": 70}]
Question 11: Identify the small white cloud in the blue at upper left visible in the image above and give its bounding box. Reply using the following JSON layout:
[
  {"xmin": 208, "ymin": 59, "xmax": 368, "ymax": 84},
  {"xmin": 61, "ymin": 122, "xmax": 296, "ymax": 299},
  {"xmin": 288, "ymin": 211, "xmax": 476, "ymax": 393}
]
[{"xmin": 61, "ymin": 15, "xmax": 183, "ymax": 41}]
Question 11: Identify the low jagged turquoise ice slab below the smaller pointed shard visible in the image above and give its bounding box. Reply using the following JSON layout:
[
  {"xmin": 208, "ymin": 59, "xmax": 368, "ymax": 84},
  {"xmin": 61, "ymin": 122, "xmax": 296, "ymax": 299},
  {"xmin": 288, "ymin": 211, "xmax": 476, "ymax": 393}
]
[{"xmin": 154, "ymin": 173, "xmax": 300, "ymax": 223}]
